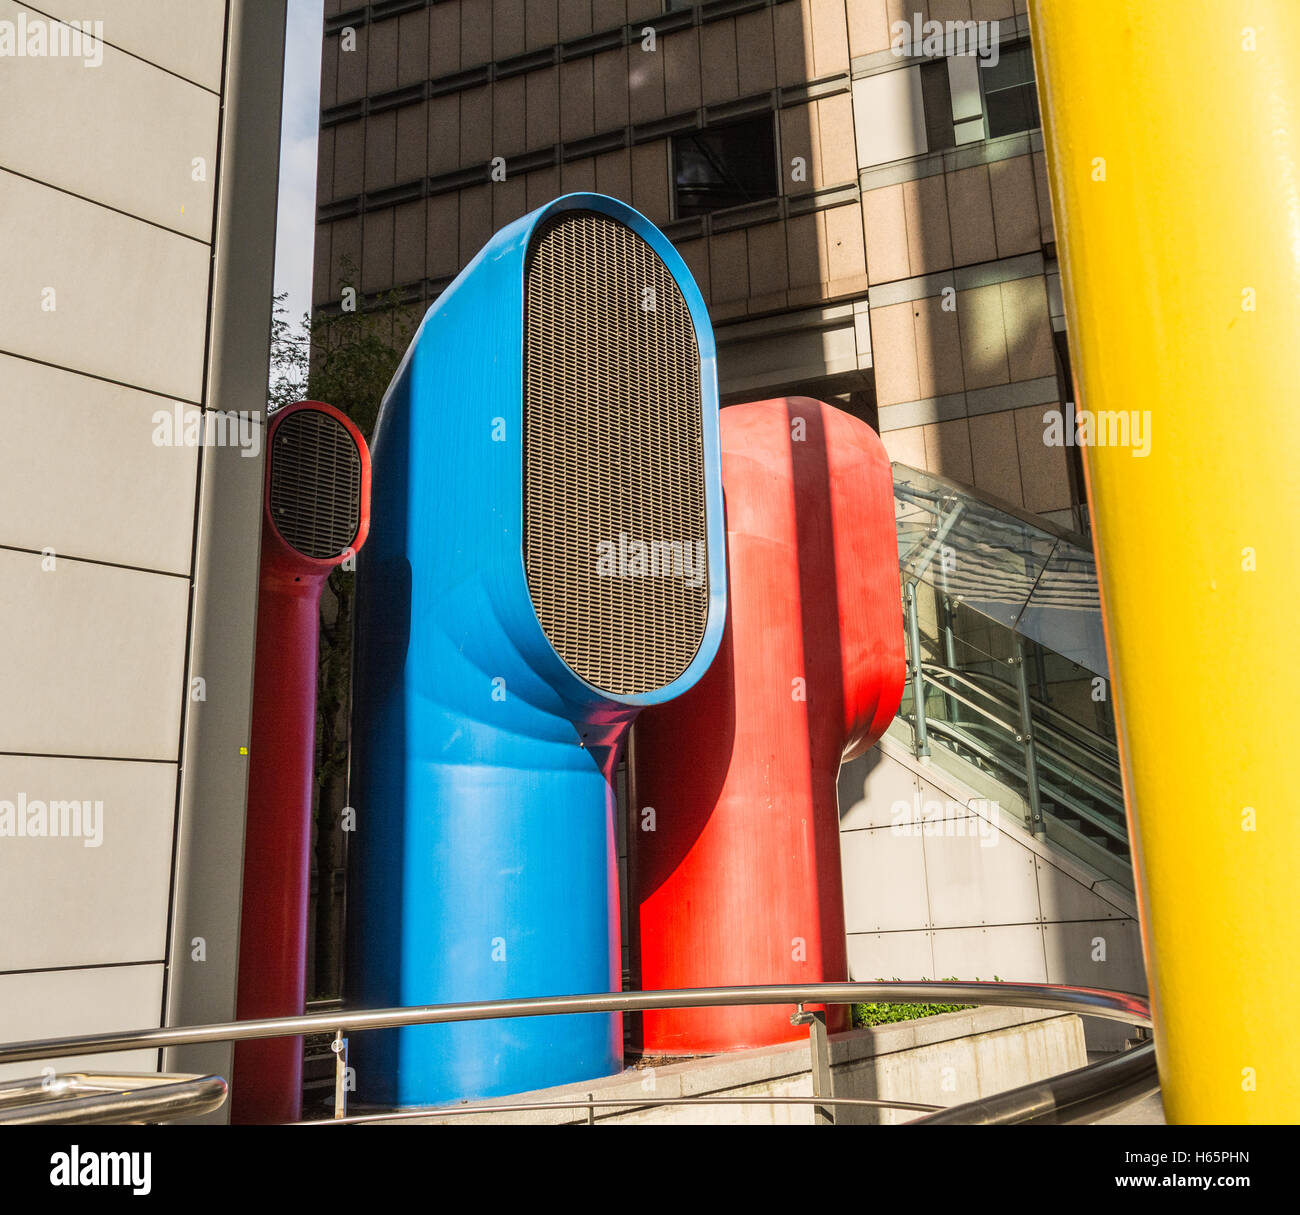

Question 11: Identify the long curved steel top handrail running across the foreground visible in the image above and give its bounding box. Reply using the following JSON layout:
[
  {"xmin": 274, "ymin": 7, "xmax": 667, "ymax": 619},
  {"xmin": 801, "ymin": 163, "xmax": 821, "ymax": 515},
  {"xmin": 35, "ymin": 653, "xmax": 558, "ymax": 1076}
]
[{"xmin": 0, "ymin": 981, "xmax": 1151, "ymax": 1121}]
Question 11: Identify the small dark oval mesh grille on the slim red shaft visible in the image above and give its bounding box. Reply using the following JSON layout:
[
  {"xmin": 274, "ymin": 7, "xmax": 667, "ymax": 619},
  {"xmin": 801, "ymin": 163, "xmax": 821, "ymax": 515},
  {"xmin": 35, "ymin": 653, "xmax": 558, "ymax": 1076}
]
[{"xmin": 270, "ymin": 409, "xmax": 361, "ymax": 560}]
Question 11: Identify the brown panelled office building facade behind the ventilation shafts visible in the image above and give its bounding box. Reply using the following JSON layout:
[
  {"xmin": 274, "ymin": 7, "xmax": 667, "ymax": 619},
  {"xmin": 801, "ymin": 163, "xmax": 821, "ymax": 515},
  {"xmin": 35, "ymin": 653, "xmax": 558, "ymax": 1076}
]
[{"xmin": 313, "ymin": 0, "xmax": 1086, "ymax": 529}]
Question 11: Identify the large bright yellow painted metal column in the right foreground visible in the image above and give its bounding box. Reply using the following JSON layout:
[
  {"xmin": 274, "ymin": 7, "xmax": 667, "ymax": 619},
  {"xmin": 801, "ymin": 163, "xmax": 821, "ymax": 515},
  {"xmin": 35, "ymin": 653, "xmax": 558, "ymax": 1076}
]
[{"xmin": 1030, "ymin": 0, "xmax": 1300, "ymax": 1123}]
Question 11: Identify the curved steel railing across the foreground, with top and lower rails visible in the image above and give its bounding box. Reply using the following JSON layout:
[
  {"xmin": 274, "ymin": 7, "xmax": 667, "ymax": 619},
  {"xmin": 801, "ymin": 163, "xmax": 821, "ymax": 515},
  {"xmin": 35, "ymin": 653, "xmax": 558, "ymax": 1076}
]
[{"xmin": 0, "ymin": 981, "xmax": 1158, "ymax": 1123}]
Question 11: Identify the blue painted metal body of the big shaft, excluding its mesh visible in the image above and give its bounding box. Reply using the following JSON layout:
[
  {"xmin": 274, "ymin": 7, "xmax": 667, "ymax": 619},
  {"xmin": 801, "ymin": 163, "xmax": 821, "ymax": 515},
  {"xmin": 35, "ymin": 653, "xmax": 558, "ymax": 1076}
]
[{"xmin": 348, "ymin": 194, "xmax": 725, "ymax": 1106}]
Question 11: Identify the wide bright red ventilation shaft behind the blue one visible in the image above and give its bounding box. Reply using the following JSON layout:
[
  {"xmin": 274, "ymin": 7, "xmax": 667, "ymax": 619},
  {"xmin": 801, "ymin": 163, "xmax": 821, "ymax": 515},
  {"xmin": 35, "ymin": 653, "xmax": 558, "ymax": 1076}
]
[{"xmin": 628, "ymin": 398, "xmax": 905, "ymax": 1055}]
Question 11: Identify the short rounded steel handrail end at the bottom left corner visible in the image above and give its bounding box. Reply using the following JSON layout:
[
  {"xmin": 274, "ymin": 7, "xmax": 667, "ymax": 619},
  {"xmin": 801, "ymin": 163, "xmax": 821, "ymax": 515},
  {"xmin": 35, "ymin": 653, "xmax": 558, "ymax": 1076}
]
[{"xmin": 0, "ymin": 1072, "xmax": 226, "ymax": 1125}]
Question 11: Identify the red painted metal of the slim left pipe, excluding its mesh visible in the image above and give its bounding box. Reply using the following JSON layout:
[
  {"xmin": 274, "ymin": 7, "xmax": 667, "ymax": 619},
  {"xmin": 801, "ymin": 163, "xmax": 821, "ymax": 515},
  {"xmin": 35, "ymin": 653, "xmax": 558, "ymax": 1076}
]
[{"xmin": 230, "ymin": 402, "xmax": 371, "ymax": 1123}]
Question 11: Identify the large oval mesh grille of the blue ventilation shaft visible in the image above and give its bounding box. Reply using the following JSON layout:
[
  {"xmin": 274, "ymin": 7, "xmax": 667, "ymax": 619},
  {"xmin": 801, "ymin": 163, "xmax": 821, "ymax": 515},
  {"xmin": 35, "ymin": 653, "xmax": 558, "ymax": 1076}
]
[{"xmin": 524, "ymin": 212, "xmax": 709, "ymax": 694}]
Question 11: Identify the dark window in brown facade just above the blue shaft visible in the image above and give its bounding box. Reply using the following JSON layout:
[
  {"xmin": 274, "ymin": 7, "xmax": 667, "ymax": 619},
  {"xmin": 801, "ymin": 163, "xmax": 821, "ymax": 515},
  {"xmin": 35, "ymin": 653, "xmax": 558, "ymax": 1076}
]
[{"xmin": 672, "ymin": 114, "xmax": 779, "ymax": 220}]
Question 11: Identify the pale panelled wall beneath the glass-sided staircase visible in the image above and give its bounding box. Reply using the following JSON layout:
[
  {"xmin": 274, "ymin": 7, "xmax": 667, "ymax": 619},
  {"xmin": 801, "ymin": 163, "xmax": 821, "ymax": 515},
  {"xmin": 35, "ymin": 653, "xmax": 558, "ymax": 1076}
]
[{"xmin": 839, "ymin": 735, "xmax": 1147, "ymax": 1050}]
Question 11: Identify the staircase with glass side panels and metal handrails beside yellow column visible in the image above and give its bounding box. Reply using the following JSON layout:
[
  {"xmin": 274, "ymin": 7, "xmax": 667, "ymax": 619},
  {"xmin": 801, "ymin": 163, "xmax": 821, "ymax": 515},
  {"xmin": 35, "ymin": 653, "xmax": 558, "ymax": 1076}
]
[{"xmin": 893, "ymin": 464, "xmax": 1132, "ymax": 890}]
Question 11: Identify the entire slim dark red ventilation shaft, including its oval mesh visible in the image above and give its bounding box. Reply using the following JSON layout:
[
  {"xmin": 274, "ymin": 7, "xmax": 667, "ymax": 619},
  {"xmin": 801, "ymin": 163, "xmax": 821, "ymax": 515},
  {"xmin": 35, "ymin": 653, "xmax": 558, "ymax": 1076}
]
[{"xmin": 230, "ymin": 400, "xmax": 371, "ymax": 1123}]
